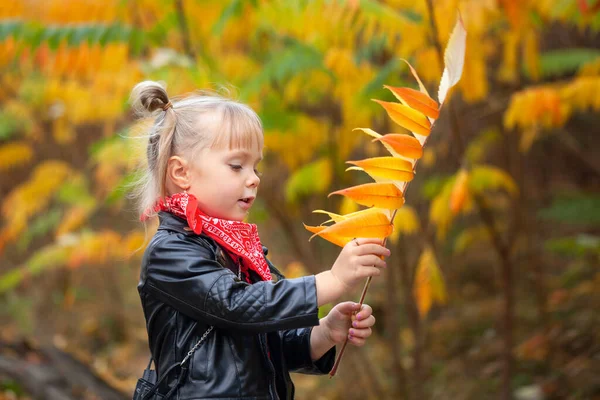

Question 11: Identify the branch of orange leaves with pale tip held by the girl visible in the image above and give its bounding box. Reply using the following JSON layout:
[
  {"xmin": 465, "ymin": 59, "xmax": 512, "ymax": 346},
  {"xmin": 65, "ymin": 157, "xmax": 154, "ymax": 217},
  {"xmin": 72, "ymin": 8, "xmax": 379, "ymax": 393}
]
[{"xmin": 305, "ymin": 15, "xmax": 466, "ymax": 377}]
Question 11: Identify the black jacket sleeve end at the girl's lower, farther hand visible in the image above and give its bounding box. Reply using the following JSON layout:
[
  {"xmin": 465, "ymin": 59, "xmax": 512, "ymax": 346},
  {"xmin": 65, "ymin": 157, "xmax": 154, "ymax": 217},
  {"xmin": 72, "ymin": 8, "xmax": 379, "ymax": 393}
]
[{"xmin": 279, "ymin": 327, "xmax": 335, "ymax": 375}]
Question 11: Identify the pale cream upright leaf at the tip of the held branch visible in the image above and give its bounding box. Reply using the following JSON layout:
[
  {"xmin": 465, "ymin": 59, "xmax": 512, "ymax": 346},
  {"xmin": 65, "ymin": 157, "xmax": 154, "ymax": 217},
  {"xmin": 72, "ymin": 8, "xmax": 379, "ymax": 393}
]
[{"xmin": 438, "ymin": 14, "xmax": 467, "ymax": 107}]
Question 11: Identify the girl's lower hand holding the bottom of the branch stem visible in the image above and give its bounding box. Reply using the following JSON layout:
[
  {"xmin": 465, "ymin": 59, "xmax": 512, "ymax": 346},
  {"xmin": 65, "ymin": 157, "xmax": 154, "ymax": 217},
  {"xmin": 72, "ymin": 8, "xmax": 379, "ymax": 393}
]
[{"xmin": 321, "ymin": 301, "xmax": 375, "ymax": 346}]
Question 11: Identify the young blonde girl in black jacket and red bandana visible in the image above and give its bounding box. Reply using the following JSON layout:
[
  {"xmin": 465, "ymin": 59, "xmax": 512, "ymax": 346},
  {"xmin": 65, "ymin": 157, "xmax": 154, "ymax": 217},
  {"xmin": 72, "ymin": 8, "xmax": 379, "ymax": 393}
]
[{"xmin": 132, "ymin": 81, "xmax": 390, "ymax": 399}]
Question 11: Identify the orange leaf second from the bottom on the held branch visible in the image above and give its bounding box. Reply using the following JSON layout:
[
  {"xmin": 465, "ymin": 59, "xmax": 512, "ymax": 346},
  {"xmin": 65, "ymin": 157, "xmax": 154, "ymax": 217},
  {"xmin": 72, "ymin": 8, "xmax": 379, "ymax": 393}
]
[{"xmin": 329, "ymin": 183, "xmax": 404, "ymax": 210}]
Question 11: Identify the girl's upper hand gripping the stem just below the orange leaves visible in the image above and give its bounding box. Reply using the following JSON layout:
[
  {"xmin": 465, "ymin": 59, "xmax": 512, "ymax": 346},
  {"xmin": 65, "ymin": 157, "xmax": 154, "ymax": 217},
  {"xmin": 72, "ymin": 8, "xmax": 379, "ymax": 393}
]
[{"xmin": 331, "ymin": 238, "xmax": 391, "ymax": 290}]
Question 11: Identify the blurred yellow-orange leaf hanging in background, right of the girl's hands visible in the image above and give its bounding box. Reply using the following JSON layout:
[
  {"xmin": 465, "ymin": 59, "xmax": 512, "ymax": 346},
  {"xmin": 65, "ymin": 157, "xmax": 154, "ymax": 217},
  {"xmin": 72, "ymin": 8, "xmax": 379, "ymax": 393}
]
[{"xmin": 414, "ymin": 247, "xmax": 447, "ymax": 317}]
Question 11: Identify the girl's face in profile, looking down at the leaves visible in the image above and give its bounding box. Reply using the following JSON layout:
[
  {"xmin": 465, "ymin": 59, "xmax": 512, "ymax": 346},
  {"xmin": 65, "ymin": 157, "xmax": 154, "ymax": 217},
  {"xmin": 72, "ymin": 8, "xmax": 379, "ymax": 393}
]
[{"xmin": 188, "ymin": 144, "xmax": 262, "ymax": 221}]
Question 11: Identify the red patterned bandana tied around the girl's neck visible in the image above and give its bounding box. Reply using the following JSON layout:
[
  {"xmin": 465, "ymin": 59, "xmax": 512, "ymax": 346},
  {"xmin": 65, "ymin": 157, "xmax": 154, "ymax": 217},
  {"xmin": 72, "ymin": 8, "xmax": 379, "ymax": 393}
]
[{"xmin": 142, "ymin": 192, "xmax": 271, "ymax": 281}]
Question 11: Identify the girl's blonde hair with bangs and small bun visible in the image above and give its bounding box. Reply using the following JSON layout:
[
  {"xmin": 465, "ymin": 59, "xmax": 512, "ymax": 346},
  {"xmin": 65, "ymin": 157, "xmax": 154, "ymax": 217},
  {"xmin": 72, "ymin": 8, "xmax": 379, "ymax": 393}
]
[{"xmin": 130, "ymin": 81, "xmax": 263, "ymax": 217}]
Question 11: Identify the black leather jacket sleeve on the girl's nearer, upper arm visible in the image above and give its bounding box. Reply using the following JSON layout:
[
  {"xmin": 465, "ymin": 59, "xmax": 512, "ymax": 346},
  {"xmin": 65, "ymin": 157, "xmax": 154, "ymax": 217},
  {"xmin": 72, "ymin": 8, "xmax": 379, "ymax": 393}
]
[{"xmin": 140, "ymin": 233, "xmax": 319, "ymax": 333}]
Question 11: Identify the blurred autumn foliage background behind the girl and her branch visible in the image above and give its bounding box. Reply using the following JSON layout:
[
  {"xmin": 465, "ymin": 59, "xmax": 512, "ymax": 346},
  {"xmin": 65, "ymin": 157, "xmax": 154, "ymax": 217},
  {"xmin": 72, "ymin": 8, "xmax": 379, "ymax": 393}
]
[{"xmin": 0, "ymin": 0, "xmax": 600, "ymax": 400}]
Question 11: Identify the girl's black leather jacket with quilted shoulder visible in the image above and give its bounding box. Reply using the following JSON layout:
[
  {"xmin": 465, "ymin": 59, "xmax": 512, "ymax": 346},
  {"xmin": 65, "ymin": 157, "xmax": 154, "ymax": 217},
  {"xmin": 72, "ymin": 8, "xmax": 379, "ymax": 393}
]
[{"xmin": 138, "ymin": 212, "xmax": 335, "ymax": 400}]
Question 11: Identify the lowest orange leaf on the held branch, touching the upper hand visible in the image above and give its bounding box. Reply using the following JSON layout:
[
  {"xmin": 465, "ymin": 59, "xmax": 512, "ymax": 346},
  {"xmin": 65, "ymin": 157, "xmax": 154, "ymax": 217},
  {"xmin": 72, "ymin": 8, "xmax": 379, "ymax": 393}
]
[{"xmin": 313, "ymin": 209, "xmax": 393, "ymax": 240}]
